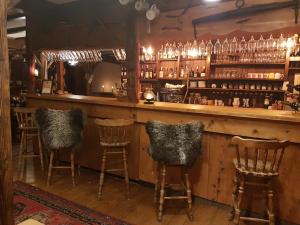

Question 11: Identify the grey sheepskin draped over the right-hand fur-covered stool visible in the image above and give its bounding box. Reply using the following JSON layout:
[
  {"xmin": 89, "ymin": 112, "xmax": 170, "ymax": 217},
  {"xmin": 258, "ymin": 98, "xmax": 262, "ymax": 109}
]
[{"xmin": 146, "ymin": 121, "xmax": 203, "ymax": 166}]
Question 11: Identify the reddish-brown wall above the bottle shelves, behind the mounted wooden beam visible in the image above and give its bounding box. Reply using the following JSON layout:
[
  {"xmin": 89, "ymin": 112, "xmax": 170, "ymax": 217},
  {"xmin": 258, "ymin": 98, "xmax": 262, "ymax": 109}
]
[{"xmin": 140, "ymin": 0, "xmax": 300, "ymax": 47}]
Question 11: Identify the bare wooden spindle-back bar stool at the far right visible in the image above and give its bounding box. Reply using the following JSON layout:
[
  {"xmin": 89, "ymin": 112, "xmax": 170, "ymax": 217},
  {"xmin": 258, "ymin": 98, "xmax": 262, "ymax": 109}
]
[{"xmin": 232, "ymin": 136, "xmax": 289, "ymax": 225}]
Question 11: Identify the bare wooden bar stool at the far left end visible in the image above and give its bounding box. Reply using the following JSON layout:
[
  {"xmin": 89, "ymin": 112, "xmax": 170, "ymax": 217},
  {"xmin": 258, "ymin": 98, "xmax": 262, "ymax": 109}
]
[{"xmin": 15, "ymin": 107, "xmax": 44, "ymax": 170}]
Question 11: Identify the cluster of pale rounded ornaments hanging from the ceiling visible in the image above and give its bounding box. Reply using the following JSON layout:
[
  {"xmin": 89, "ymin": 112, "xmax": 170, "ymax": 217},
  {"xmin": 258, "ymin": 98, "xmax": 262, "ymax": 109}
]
[{"xmin": 119, "ymin": 0, "xmax": 160, "ymax": 21}]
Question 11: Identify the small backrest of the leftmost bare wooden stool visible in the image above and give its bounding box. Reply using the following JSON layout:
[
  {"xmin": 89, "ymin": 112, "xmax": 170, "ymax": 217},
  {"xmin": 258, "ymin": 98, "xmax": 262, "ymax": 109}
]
[{"xmin": 14, "ymin": 107, "xmax": 37, "ymax": 129}]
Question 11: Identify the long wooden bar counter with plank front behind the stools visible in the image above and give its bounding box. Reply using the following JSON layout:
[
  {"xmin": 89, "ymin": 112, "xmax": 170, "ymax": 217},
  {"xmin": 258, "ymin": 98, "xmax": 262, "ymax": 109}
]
[{"xmin": 27, "ymin": 95, "xmax": 300, "ymax": 223}]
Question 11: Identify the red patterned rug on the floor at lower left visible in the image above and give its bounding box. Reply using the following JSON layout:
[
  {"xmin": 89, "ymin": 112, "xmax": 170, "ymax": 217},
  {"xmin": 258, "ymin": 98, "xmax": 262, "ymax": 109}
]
[{"xmin": 14, "ymin": 182, "xmax": 129, "ymax": 225}]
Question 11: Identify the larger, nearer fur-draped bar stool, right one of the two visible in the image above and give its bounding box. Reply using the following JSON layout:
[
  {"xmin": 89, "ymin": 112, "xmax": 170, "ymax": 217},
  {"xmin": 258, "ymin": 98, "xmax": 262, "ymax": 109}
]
[{"xmin": 146, "ymin": 121, "xmax": 203, "ymax": 221}]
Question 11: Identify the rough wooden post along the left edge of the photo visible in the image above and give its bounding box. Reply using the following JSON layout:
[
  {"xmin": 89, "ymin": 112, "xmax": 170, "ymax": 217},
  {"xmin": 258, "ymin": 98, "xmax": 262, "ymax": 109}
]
[{"xmin": 0, "ymin": 0, "xmax": 14, "ymax": 225}]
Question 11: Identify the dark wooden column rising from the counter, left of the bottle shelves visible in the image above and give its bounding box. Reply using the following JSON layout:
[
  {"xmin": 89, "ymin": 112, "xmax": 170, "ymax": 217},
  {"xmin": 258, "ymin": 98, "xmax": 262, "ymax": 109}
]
[{"xmin": 126, "ymin": 9, "xmax": 138, "ymax": 102}]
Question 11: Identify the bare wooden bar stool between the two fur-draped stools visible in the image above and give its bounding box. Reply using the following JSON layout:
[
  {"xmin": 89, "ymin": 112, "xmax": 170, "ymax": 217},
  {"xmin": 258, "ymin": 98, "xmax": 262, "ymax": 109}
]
[{"xmin": 95, "ymin": 119, "xmax": 134, "ymax": 199}]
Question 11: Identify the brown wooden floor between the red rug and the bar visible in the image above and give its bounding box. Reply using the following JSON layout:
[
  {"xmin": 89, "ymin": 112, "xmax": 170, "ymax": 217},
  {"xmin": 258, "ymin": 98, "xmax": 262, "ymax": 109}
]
[{"xmin": 14, "ymin": 146, "xmax": 248, "ymax": 225}]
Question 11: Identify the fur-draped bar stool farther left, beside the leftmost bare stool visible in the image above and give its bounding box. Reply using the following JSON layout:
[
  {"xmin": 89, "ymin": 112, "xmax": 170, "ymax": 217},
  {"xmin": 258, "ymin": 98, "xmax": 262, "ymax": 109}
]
[{"xmin": 36, "ymin": 108, "xmax": 85, "ymax": 185}]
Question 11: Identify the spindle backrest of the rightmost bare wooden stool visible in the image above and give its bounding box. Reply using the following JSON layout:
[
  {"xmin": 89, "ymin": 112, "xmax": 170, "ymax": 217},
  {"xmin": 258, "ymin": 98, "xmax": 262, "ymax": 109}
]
[{"xmin": 232, "ymin": 136, "xmax": 289, "ymax": 174}]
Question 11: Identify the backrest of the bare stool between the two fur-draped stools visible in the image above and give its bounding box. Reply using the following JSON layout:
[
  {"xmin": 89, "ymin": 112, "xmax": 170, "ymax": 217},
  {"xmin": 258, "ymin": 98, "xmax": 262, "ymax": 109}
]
[{"xmin": 95, "ymin": 119, "xmax": 134, "ymax": 145}]
